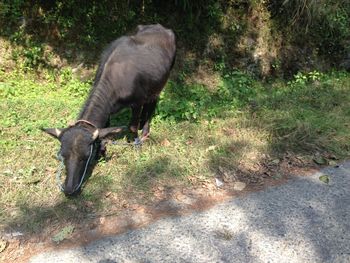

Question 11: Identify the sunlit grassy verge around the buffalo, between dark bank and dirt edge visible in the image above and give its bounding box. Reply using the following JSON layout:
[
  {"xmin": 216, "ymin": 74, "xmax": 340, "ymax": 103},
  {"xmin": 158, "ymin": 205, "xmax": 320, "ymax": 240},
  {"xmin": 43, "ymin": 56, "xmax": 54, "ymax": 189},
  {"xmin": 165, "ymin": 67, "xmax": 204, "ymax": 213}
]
[{"xmin": 0, "ymin": 69, "xmax": 350, "ymax": 237}]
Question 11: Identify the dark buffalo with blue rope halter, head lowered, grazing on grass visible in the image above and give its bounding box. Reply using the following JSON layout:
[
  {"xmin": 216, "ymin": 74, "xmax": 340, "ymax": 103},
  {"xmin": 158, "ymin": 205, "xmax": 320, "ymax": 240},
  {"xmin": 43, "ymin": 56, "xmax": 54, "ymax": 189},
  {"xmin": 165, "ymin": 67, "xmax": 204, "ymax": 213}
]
[{"xmin": 43, "ymin": 24, "xmax": 176, "ymax": 196}]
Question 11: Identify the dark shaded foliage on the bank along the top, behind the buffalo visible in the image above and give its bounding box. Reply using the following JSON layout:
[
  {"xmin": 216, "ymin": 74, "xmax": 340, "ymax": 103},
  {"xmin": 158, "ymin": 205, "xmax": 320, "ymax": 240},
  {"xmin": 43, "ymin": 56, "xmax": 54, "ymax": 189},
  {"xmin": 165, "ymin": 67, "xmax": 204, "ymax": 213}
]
[{"xmin": 0, "ymin": 0, "xmax": 350, "ymax": 75}]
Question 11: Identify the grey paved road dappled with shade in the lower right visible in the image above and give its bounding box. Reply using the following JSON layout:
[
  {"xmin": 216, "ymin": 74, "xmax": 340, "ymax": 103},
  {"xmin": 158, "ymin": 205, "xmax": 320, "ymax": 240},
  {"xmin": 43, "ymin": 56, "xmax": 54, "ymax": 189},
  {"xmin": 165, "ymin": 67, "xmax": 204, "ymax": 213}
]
[{"xmin": 30, "ymin": 162, "xmax": 350, "ymax": 263}]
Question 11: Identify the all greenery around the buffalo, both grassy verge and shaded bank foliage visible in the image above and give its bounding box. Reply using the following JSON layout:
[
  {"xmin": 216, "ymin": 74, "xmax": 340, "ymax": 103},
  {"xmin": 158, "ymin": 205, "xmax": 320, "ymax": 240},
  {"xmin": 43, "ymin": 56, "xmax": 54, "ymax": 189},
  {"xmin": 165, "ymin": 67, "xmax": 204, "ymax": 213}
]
[{"xmin": 0, "ymin": 0, "xmax": 350, "ymax": 248}]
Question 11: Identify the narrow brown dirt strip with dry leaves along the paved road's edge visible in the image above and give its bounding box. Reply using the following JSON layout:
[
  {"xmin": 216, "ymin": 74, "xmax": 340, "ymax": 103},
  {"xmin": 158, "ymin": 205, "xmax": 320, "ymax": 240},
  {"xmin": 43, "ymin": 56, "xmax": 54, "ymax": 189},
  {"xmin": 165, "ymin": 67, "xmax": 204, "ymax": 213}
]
[{"xmin": 0, "ymin": 155, "xmax": 326, "ymax": 262}]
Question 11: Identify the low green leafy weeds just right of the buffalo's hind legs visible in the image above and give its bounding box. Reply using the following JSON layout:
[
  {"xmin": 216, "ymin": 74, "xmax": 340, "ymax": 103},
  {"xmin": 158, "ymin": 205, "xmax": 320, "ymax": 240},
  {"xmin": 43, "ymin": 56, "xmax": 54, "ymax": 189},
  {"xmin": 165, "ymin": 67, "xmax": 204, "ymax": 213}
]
[{"xmin": 157, "ymin": 71, "xmax": 256, "ymax": 121}]
